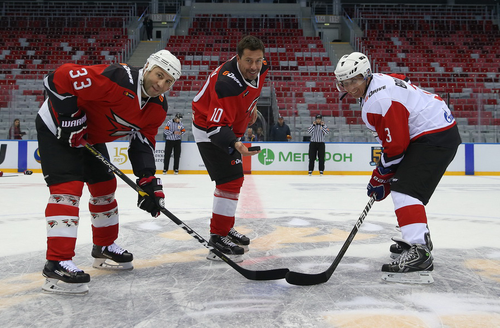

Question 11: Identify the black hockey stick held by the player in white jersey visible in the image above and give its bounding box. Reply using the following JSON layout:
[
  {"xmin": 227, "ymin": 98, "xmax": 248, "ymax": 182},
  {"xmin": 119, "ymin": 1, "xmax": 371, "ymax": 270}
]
[{"xmin": 285, "ymin": 196, "xmax": 375, "ymax": 286}]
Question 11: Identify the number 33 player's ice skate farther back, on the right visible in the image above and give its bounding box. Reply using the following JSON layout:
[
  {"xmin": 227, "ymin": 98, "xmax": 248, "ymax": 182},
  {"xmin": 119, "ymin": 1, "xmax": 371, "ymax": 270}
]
[{"xmin": 92, "ymin": 243, "xmax": 134, "ymax": 270}]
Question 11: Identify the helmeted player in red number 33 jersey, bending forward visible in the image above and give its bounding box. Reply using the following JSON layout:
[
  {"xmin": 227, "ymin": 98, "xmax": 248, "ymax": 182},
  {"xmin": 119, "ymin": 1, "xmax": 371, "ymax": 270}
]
[{"xmin": 36, "ymin": 50, "xmax": 181, "ymax": 293}]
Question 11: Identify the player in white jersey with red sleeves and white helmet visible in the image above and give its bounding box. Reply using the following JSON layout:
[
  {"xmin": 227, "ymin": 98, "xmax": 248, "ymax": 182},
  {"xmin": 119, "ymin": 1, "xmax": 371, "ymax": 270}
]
[{"xmin": 335, "ymin": 52, "xmax": 461, "ymax": 283}]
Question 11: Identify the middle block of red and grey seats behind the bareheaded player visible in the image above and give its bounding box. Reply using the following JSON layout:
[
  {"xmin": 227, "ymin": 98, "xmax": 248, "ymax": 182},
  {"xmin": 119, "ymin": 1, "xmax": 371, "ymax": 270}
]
[{"xmin": 167, "ymin": 14, "xmax": 361, "ymax": 140}]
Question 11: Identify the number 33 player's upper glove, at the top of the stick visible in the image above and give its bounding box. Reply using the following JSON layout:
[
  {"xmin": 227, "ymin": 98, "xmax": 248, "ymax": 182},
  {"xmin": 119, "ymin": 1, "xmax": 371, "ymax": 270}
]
[{"xmin": 56, "ymin": 113, "xmax": 87, "ymax": 148}]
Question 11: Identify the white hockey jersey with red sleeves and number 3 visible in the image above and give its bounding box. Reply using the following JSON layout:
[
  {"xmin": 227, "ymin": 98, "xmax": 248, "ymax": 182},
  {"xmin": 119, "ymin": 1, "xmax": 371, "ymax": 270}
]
[{"xmin": 360, "ymin": 74, "xmax": 456, "ymax": 167}]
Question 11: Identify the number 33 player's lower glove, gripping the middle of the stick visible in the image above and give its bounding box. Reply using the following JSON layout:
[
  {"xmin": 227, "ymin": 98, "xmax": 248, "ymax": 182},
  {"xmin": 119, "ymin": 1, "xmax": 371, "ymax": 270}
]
[{"xmin": 137, "ymin": 176, "xmax": 165, "ymax": 218}]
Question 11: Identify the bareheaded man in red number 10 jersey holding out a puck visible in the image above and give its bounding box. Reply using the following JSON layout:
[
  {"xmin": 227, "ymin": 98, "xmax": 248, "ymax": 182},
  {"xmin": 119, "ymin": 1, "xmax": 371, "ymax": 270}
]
[{"xmin": 193, "ymin": 36, "xmax": 268, "ymax": 261}]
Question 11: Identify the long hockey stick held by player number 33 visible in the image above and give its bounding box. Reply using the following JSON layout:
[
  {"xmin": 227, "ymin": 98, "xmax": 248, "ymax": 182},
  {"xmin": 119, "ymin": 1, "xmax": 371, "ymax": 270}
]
[{"xmin": 85, "ymin": 143, "xmax": 290, "ymax": 280}]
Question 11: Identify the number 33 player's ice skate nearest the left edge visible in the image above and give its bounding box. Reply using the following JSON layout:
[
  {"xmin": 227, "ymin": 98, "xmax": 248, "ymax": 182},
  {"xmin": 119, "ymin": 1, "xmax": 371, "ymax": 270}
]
[{"xmin": 42, "ymin": 260, "xmax": 90, "ymax": 295}]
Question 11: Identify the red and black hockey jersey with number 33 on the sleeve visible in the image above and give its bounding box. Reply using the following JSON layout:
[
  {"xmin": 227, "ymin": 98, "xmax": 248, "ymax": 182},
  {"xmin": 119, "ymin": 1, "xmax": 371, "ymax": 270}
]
[{"xmin": 39, "ymin": 64, "xmax": 168, "ymax": 178}]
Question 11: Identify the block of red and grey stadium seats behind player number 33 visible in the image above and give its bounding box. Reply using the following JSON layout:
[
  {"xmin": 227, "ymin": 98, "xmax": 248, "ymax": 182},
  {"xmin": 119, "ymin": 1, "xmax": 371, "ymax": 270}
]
[{"xmin": 0, "ymin": 2, "xmax": 136, "ymax": 138}]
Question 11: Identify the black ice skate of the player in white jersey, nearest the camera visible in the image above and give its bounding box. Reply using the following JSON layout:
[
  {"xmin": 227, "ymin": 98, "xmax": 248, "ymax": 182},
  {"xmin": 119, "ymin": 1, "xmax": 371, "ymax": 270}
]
[{"xmin": 382, "ymin": 238, "xmax": 434, "ymax": 284}]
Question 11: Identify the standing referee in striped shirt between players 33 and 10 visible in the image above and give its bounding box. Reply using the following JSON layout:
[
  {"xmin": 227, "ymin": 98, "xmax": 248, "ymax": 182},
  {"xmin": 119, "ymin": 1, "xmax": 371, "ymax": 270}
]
[{"xmin": 163, "ymin": 113, "xmax": 186, "ymax": 174}]
